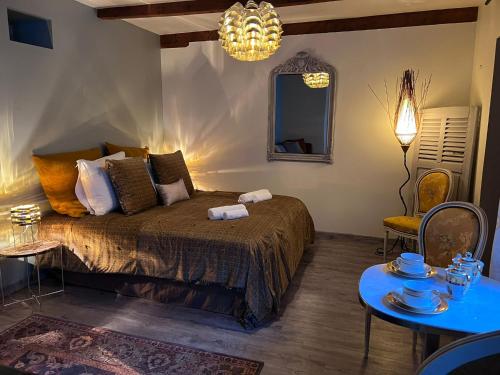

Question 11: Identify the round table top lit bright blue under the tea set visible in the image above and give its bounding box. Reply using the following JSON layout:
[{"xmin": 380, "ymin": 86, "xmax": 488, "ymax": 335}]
[{"xmin": 359, "ymin": 264, "xmax": 500, "ymax": 334}]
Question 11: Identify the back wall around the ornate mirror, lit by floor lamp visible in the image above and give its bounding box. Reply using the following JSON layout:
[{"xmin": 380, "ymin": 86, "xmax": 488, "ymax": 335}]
[{"xmin": 162, "ymin": 23, "xmax": 475, "ymax": 236}]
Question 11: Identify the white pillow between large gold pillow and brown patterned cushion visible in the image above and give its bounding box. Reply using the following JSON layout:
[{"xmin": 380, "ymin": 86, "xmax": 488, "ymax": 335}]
[{"xmin": 75, "ymin": 151, "xmax": 125, "ymax": 216}]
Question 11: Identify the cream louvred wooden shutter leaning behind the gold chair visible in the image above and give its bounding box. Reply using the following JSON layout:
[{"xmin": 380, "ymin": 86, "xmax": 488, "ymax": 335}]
[{"xmin": 412, "ymin": 107, "xmax": 479, "ymax": 201}]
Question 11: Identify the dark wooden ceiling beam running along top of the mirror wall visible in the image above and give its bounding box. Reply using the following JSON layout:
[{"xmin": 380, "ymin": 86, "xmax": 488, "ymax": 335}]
[{"xmin": 161, "ymin": 7, "xmax": 478, "ymax": 48}]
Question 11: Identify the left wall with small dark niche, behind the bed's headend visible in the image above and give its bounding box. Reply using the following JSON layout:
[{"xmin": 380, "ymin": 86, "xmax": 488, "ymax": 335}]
[{"xmin": 0, "ymin": 0, "xmax": 162, "ymax": 288}]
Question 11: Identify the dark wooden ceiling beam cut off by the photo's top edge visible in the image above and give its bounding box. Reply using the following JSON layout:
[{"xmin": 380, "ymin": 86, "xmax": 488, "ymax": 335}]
[{"xmin": 97, "ymin": 0, "xmax": 340, "ymax": 20}]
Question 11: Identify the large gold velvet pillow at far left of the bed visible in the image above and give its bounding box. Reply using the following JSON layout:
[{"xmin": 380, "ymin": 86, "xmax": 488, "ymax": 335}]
[{"xmin": 33, "ymin": 148, "xmax": 102, "ymax": 217}]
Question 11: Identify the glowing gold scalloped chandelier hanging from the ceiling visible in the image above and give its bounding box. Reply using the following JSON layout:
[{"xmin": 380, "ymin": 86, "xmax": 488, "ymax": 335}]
[{"xmin": 219, "ymin": 0, "xmax": 283, "ymax": 61}]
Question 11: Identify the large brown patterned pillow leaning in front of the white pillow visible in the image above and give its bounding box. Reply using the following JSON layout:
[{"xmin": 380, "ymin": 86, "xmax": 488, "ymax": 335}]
[{"xmin": 106, "ymin": 157, "xmax": 157, "ymax": 215}]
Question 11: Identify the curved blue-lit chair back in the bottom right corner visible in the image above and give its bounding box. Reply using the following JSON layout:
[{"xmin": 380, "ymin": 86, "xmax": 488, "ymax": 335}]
[{"xmin": 416, "ymin": 331, "xmax": 500, "ymax": 375}]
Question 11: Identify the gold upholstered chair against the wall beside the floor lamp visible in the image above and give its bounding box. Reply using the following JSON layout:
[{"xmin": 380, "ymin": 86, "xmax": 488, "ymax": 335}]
[{"xmin": 384, "ymin": 168, "xmax": 453, "ymax": 262}]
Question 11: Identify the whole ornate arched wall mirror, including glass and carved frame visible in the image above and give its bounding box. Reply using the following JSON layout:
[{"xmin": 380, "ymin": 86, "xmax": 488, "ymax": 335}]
[{"xmin": 267, "ymin": 52, "xmax": 335, "ymax": 163}]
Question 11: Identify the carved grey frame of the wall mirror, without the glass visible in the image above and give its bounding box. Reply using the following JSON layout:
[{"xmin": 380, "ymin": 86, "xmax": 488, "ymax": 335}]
[{"xmin": 267, "ymin": 51, "xmax": 337, "ymax": 164}]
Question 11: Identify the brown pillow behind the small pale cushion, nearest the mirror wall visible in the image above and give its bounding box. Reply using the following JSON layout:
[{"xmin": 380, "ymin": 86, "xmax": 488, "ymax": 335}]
[{"xmin": 149, "ymin": 151, "xmax": 194, "ymax": 195}]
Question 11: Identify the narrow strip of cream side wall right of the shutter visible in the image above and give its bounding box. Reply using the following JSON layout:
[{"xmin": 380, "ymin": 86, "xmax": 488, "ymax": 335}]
[{"xmin": 471, "ymin": 1, "xmax": 500, "ymax": 204}]
